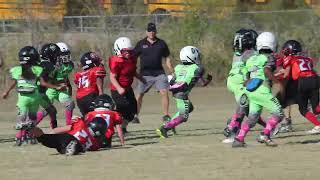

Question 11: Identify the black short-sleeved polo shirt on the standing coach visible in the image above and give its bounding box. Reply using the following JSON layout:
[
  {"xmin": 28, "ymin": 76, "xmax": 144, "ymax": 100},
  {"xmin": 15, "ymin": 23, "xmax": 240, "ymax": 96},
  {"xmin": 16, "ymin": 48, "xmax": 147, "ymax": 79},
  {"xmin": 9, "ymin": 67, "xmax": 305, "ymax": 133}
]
[{"xmin": 134, "ymin": 38, "xmax": 170, "ymax": 76}]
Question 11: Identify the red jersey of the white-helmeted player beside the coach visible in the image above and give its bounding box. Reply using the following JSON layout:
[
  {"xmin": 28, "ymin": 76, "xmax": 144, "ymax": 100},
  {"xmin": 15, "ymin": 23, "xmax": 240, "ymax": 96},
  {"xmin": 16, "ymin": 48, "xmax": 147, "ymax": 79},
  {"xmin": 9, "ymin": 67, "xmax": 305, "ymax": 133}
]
[{"xmin": 109, "ymin": 56, "xmax": 137, "ymax": 90}]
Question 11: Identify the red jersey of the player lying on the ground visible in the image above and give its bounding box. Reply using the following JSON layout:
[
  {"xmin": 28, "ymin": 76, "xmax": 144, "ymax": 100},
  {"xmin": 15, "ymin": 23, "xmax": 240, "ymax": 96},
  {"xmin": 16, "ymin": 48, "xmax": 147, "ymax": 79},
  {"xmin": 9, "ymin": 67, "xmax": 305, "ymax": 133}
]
[{"xmin": 67, "ymin": 118, "xmax": 100, "ymax": 151}]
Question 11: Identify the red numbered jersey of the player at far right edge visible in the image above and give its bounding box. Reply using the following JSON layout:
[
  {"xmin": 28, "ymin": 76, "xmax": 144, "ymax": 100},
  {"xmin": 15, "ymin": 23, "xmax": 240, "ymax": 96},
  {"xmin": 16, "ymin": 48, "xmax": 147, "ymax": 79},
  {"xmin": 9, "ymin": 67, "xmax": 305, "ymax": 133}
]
[{"xmin": 284, "ymin": 56, "xmax": 317, "ymax": 80}]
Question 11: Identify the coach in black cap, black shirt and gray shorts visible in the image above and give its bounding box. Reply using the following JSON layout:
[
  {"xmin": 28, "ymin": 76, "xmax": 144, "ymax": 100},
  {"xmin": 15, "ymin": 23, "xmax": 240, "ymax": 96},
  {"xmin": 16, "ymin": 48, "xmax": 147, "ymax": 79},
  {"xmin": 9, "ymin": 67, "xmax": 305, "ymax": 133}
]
[{"xmin": 133, "ymin": 23, "xmax": 173, "ymax": 123}]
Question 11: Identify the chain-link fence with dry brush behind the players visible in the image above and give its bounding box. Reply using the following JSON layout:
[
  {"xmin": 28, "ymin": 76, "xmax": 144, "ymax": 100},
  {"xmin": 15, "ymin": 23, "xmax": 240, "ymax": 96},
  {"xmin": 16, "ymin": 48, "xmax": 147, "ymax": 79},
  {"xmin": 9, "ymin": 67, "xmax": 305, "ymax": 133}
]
[{"xmin": 0, "ymin": 9, "xmax": 320, "ymax": 86}]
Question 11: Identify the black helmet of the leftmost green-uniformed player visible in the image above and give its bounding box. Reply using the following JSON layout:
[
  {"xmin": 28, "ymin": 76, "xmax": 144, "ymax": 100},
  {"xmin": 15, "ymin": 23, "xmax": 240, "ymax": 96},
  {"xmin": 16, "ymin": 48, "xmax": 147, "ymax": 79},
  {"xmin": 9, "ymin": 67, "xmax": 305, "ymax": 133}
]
[{"xmin": 18, "ymin": 46, "xmax": 40, "ymax": 64}]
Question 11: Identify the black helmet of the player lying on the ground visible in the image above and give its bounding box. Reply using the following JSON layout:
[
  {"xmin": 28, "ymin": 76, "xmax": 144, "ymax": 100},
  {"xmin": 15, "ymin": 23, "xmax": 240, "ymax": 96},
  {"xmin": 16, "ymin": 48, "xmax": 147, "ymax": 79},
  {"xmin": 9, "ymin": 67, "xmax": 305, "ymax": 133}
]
[{"xmin": 88, "ymin": 117, "xmax": 108, "ymax": 139}]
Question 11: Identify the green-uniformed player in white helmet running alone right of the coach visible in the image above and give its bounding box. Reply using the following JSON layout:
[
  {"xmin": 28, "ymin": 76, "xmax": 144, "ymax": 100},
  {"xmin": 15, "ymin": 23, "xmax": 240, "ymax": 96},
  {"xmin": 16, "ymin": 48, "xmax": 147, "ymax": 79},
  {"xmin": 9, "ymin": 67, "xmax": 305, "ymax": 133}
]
[{"xmin": 156, "ymin": 46, "xmax": 212, "ymax": 138}]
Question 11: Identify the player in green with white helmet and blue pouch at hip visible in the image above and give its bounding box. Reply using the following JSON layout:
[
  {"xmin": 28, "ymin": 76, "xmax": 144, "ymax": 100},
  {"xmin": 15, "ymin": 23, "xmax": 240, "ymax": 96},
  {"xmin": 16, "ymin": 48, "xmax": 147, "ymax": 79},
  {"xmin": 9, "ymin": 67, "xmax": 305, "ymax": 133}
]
[{"xmin": 232, "ymin": 32, "xmax": 284, "ymax": 147}]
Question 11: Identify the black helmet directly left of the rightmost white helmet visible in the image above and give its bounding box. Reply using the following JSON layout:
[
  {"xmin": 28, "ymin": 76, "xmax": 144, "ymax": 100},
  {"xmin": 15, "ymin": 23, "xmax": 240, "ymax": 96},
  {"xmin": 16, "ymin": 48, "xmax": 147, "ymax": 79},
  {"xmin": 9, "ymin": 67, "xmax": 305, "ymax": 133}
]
[{"xmin": 233, "ymin": 29, "xmax": 258, "ymax": 53}]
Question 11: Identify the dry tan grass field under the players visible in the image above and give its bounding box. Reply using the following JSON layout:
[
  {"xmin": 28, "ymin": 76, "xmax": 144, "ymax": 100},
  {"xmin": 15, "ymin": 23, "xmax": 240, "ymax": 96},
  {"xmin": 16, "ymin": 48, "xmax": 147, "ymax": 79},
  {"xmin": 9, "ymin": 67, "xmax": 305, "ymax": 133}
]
[{"xmin": 0, "ymin": 88, "xmax": 320, "ymax": 180}]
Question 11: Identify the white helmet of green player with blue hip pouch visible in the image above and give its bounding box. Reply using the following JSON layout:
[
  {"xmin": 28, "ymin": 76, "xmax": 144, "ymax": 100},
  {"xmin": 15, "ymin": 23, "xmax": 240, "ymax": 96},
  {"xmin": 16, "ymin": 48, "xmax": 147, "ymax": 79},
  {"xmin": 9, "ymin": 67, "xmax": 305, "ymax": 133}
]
[{"xmin": 257, "ymin": 32, "xmax": 277, "ymax": 52}]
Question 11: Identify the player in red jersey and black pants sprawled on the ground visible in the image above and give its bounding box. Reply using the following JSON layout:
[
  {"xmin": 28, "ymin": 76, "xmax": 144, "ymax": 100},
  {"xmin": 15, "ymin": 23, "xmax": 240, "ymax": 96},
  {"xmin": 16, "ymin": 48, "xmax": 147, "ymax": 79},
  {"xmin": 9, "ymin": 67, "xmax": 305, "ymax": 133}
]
[{"xmin": 31, "ymin": 117, "xmax": 108, "ymax": 155}]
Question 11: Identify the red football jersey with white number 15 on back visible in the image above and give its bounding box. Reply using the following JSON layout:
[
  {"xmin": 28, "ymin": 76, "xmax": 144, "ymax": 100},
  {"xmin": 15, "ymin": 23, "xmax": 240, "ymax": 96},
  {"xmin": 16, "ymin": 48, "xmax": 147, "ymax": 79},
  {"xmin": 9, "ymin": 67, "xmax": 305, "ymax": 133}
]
[{"xmin": 74, "ymin": 66, "xmax": 106, "ymax": 99}]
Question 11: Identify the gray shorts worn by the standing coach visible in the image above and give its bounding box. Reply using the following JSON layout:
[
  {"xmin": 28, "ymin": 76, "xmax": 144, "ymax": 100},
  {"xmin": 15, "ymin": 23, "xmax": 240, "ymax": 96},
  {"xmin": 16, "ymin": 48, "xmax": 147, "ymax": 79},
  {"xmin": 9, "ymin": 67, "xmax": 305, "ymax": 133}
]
[{"xmin": 137, "ymin": 74, "xmax": 169, "ymax": 94}]
